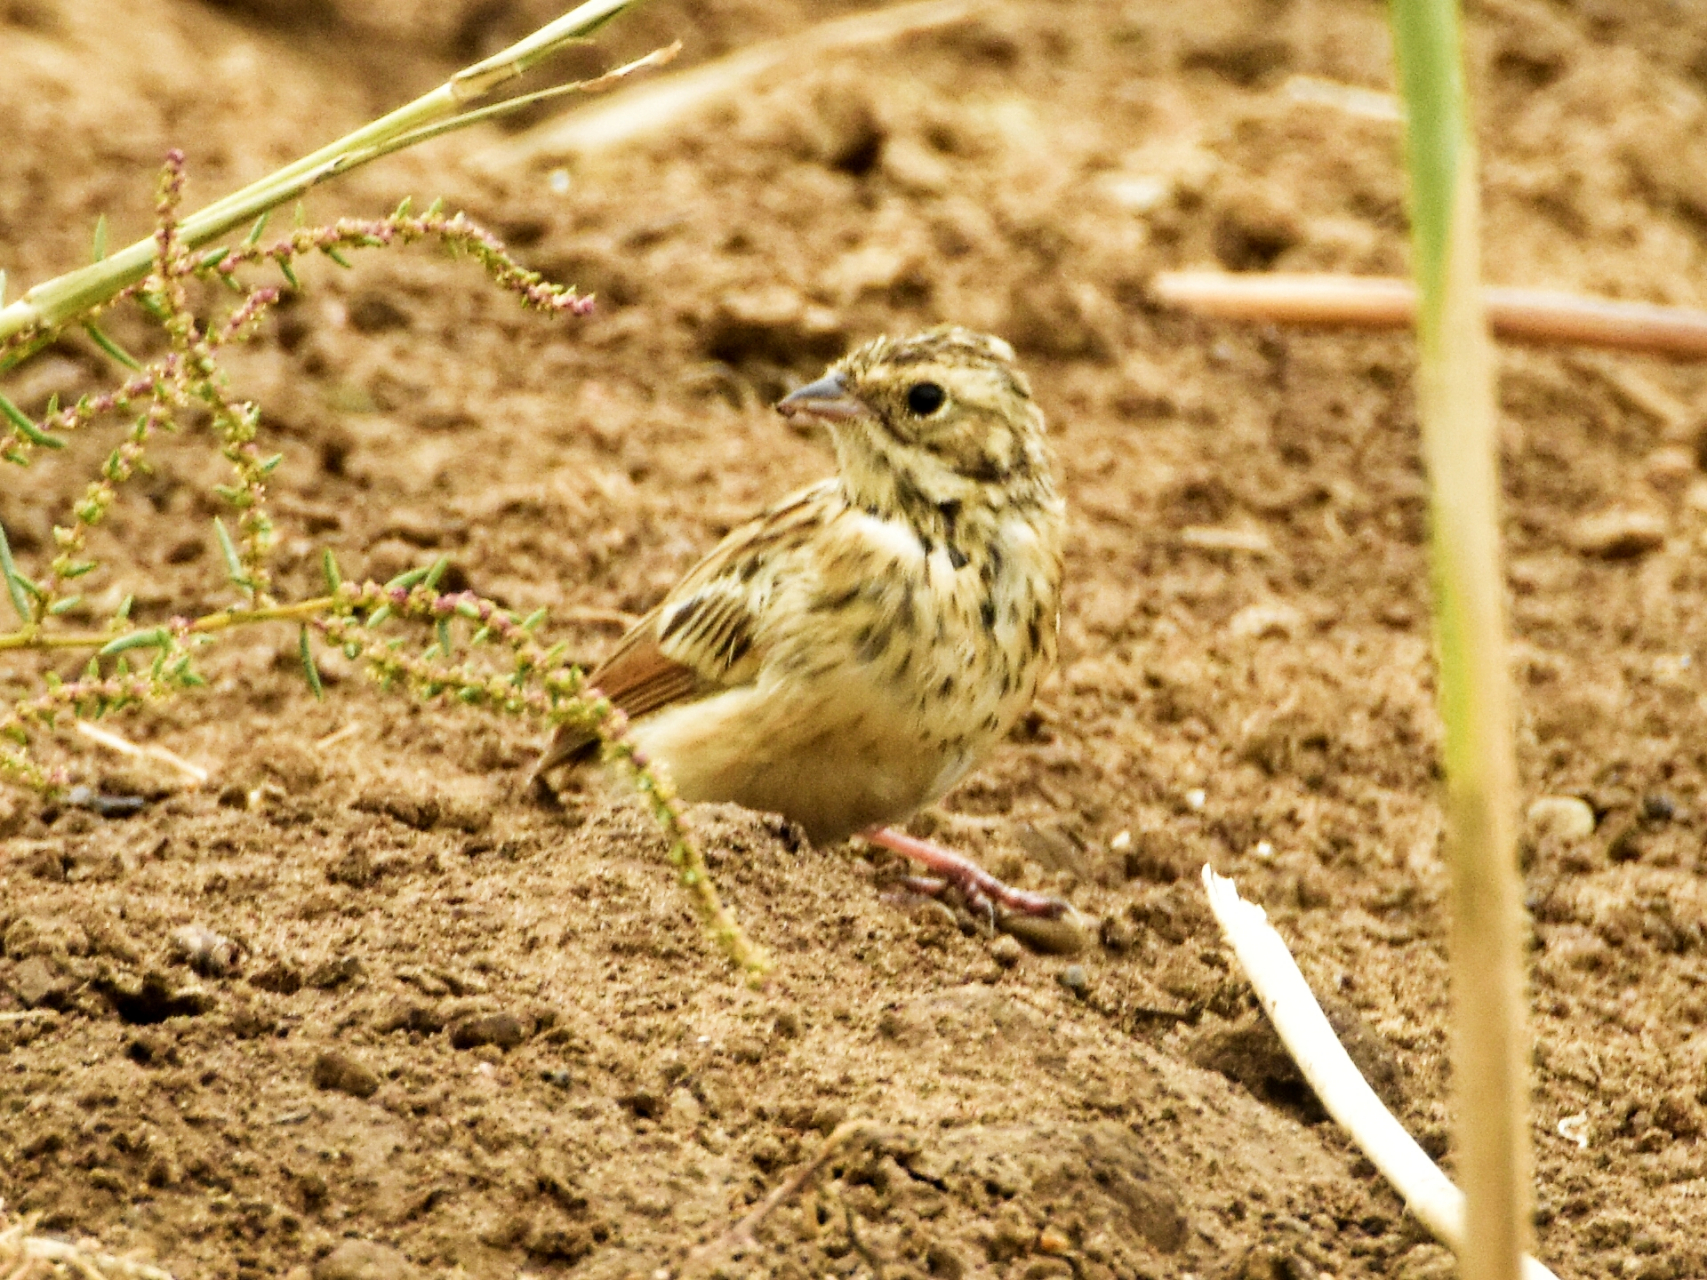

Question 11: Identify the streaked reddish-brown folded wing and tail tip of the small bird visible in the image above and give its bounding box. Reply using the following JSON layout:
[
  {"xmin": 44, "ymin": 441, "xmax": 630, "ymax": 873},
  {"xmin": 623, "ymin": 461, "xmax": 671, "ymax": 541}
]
[{"xmin": 534, "ymin": 480, "xmax": 836, "ymax": 777}]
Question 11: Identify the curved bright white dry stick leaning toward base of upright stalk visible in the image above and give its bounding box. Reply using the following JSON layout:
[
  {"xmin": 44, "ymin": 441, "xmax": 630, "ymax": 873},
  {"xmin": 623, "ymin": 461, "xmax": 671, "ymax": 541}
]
[{"xmin": 1203, "ymin": 865, "xmax": 1557, "ymax": 1280}]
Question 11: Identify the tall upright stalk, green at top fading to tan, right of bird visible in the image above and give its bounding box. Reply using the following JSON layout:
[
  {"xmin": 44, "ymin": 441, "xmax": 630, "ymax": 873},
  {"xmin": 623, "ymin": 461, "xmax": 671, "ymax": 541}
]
[{"xmin": 1393, "ymin": 0, "xmax": 1529, "ymax": 1280}]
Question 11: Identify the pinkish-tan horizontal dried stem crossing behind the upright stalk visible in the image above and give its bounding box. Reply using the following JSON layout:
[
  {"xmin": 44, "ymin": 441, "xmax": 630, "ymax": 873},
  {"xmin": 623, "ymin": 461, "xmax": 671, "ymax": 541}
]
[{"xmin": 1151, "ymin": 271, "xmax": 1707, "ymax": 360}]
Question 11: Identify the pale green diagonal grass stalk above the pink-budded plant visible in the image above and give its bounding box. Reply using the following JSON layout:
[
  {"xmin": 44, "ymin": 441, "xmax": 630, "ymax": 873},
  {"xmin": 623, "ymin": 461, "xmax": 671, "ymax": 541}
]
[{"xmin": 0, "ymin": 0, "xmax": 635, "ymax": 341}]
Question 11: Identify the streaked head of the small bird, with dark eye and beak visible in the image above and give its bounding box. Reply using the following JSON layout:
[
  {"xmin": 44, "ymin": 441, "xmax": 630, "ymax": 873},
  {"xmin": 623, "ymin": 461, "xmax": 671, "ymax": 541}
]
[{"xmin": 777, "ymin": 324, "xmax": 1053, "ymax": 517}]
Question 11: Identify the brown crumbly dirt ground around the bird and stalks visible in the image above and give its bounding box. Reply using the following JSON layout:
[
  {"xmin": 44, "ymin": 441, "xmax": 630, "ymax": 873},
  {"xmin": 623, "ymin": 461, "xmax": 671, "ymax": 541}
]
[{"xmin": 0, "ymin": 0, "xmax": 1707, "ymax": 1280}]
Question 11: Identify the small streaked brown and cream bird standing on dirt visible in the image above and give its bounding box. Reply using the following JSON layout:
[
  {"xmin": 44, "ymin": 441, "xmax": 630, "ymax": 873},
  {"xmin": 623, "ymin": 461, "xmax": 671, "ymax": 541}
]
[{"xmin": 531, "ymin": 324, "xmax": 1065, "ymax": 915}]
